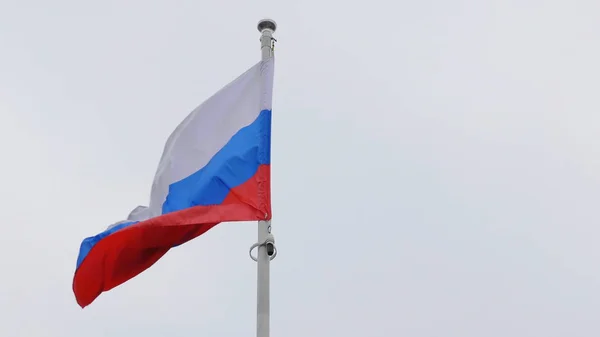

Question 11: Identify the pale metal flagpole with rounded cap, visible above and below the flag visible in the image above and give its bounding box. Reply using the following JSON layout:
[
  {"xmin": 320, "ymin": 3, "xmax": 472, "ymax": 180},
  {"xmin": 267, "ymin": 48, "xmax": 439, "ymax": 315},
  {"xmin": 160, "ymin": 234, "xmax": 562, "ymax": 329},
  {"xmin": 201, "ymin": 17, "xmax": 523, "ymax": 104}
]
[{"xmin": 250, "ymin": 19, "xmax": 277, "ymax": 337}]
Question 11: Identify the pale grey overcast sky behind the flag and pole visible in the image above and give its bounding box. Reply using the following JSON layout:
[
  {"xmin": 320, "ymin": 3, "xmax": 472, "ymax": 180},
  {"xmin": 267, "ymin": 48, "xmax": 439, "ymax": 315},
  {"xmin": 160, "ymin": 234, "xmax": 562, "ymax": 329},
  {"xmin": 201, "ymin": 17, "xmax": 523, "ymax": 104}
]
[{"xmin": 0, "ymin": 0, "xmax": 600, "ymax": 337}]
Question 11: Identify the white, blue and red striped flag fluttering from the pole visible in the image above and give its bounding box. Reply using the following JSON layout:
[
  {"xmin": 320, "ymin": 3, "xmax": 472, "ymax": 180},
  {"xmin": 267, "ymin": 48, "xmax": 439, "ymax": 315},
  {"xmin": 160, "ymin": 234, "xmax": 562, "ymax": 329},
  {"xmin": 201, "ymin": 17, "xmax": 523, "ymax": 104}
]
[{"xmin": 73, "ymin": 58, "xmax": 274, "ymax": 307}]
